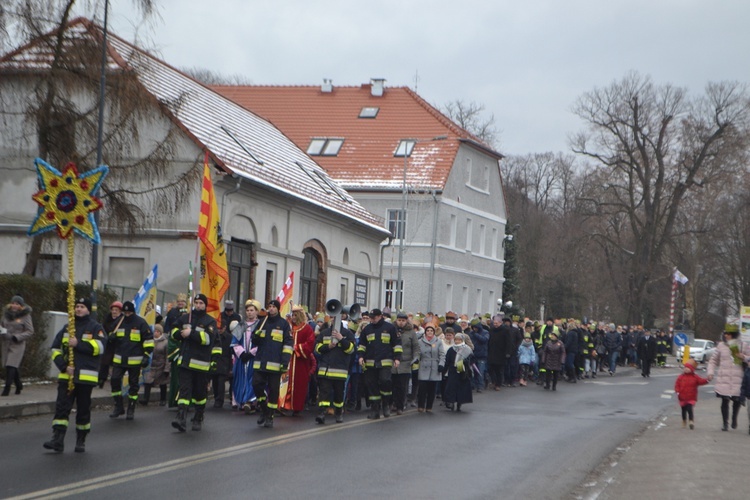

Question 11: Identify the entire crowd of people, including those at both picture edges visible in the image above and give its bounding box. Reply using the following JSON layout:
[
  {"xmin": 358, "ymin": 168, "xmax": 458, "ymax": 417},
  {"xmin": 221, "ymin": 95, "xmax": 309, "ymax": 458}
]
[{"xmin": 2, "ymin": 294, "xmax": 750, "ymax": 452}]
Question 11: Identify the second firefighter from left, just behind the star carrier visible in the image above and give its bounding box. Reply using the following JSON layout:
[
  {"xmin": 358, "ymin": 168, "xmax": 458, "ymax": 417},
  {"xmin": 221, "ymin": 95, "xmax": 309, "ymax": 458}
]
[{"xmin": 109, "ymin": 301, "xmax": 154, "ymax": 420}]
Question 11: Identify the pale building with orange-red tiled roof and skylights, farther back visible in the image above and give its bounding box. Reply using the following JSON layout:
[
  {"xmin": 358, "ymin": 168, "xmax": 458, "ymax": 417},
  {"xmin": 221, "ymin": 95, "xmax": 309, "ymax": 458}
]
[{"xmin": 212, "ymin": 79, "xmax": 507, "ymax": 313}]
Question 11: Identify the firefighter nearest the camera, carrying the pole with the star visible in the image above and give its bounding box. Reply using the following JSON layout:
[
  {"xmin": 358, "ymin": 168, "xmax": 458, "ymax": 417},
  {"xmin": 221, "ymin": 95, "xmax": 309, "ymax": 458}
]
[{"xmin": 44, "ymin": 298, "xmax": 107, "ymax": 453}]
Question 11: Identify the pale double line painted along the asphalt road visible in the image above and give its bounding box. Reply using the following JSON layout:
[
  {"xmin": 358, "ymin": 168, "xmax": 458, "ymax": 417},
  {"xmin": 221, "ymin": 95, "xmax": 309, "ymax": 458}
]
[{"xmin": 8, "ymin": 413, "xmax": 396, "ymax": 500}]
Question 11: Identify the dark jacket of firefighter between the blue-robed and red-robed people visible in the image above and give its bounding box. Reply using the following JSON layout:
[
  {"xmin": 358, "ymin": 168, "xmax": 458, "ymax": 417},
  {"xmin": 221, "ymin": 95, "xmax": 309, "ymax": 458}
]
[{"xmin": 253, "ymin": 315, "xmax": 294, "ymax": 372}]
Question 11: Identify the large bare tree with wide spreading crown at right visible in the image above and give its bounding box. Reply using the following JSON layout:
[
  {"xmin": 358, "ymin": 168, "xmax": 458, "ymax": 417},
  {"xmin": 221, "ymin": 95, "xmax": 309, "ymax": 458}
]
[{"xmin": 572, "ymin": 73, "xmax": 750, "ymax": 323}]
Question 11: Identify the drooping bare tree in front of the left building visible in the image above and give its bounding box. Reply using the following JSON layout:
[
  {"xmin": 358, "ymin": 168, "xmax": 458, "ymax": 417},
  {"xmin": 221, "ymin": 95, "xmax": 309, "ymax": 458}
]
[{"xmin": 0, "ymin": 0, "xmax": 200, "ymax": 274}]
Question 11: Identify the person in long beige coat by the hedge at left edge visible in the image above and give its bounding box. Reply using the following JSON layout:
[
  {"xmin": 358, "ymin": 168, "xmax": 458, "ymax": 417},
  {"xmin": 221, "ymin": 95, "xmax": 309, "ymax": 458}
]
[{"xmin": 0, "ymin": 295, "xmax": 34, "ymax": 396}]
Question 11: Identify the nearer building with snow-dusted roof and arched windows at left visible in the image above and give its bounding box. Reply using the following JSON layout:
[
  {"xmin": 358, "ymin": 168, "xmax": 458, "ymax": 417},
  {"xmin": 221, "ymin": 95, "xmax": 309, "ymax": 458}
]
[{"xmin": 0, "ymin": 19, "xmax": 388, "ymax": 311}]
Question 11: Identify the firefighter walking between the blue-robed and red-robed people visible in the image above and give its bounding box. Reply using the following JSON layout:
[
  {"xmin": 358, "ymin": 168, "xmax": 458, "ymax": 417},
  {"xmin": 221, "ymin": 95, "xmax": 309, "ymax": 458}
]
[{"xmin": 253, "ymin": 299, "xmax": 294, "ymax": 428}]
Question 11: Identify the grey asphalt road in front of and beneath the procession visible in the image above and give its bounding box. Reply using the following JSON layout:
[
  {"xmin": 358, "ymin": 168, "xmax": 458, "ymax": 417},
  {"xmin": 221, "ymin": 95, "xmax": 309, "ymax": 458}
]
[{"xmin": 0, "ymin": 369, "xmax": 674, "ymax": 499}]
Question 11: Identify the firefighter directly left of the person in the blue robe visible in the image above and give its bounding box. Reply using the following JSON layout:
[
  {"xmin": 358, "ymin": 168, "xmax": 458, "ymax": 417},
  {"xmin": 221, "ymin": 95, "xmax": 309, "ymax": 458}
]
[{"xmin": 172, "ymin": 293, "xmax": 221, "ymax": 432}]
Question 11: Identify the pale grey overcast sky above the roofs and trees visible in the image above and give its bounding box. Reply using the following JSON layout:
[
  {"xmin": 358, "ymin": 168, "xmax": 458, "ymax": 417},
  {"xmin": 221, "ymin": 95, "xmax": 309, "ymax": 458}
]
[{"xmin": 97, "ymin": 0, "xmax": 750, "ymax": 154}]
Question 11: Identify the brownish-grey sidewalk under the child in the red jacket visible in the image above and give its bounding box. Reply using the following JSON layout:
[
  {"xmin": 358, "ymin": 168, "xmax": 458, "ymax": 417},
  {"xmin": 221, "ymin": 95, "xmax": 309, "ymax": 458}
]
[{"xmin": 569, "ymin": 357, "xmax": 750, "ymax": 500}]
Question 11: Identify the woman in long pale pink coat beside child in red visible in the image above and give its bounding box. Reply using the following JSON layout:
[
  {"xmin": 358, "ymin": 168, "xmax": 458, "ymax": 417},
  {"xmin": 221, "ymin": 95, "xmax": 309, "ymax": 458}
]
[{"xmin": 708, "ymin": 324, "xmax": 750, "ymax": 431}]
